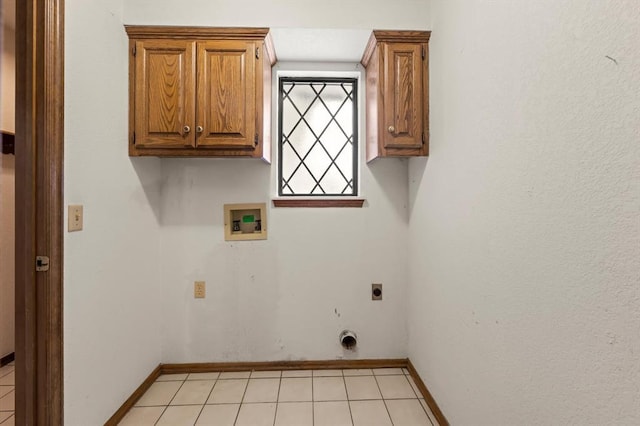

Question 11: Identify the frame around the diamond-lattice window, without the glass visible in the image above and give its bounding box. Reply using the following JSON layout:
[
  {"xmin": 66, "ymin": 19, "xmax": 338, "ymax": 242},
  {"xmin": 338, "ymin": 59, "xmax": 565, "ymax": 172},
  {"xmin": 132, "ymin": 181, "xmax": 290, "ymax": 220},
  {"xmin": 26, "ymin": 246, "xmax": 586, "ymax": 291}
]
[{"xmin": 274, "ymin": 72, "xmax": 361, "ymax": 197}]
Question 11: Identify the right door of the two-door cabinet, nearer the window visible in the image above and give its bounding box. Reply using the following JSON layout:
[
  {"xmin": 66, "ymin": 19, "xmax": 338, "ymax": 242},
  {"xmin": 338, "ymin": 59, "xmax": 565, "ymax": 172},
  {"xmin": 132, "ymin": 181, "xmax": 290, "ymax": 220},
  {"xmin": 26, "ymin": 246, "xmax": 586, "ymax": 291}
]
[{"xmin": 196, "ymin": 41, "xmax": 257, "ymax": 150}]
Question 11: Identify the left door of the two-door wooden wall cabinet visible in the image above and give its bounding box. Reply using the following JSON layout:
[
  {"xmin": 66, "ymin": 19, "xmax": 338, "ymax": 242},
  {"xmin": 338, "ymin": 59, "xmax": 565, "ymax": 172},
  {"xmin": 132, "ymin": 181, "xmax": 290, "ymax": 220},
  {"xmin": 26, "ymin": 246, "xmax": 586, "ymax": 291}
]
[{"xmin": 134, "ymin": 40, "xmax": 195, "ymax": 148}]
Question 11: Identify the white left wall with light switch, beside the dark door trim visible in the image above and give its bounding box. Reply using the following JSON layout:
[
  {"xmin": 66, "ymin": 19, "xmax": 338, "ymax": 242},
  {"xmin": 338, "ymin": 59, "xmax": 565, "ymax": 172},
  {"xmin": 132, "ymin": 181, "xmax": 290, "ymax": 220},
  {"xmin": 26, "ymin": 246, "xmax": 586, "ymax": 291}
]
[{"xmin": 64, "ymin": 0, "xmax": 162, "ymax": 426}]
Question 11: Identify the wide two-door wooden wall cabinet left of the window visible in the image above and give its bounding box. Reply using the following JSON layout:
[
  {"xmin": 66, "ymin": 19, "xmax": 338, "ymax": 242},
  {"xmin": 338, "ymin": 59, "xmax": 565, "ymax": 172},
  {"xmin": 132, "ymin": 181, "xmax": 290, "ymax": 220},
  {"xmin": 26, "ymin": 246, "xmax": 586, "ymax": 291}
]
[{"xmin": 126, "ymin": 26, "xmax": 275, "ymax": 161}]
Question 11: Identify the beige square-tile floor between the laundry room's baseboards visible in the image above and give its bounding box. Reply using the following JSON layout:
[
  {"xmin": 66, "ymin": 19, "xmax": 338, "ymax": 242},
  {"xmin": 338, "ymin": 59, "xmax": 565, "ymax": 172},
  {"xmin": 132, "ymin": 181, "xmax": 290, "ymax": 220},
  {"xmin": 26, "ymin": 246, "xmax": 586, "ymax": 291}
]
[{"xmin": 120, "ymin": 368, "xmax": 438, "ymax": 426}]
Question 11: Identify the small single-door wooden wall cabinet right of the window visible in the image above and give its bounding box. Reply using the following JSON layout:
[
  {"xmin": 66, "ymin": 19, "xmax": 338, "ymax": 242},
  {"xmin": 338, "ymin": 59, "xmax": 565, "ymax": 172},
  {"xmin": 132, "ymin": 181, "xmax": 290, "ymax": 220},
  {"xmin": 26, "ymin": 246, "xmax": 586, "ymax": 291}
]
[{"xmin": 361, "ymin": 30, "xmax": 431, "ymax": 161}]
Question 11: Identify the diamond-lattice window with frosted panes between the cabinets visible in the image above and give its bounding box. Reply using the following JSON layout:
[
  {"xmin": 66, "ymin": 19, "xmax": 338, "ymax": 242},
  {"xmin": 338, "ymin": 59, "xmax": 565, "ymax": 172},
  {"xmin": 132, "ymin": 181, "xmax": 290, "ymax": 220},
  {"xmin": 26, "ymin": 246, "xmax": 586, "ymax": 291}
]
[{"xmin": 278, "ymin": 77, "xmax": 358, "ymax": 196}]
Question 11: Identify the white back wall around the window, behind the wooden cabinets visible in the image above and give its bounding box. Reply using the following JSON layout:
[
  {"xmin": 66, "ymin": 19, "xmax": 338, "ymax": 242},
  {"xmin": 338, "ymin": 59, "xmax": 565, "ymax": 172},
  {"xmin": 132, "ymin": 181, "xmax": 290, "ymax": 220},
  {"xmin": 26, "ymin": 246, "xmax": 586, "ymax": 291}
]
[{"xmin": 125, "ymin": 0, "xmax": 428, "ymax": 362}]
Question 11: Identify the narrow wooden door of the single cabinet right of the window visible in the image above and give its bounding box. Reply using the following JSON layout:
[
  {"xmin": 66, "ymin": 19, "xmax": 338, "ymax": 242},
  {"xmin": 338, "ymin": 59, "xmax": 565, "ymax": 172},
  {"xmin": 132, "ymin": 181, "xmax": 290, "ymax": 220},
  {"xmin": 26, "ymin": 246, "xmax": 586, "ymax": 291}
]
[{"xmin": 380, "ymin": 43, "xmax": 423, "ymax": 148}]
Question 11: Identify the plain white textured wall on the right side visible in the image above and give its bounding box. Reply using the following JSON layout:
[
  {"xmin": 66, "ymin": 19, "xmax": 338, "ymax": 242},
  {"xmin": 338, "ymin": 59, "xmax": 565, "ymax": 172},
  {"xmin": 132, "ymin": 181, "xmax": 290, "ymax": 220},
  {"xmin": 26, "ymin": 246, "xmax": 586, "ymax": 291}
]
[{"xmin": 409, "ymin": 0, "xmax": 640, "ymax": 425}]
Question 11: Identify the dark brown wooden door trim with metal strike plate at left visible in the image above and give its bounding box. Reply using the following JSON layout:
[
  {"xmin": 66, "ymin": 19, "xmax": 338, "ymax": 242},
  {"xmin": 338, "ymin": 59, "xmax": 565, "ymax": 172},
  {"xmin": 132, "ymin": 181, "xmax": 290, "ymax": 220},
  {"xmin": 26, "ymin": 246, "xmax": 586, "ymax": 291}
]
[{"xmin": 16, "ymin": 0, "xmax": 64, "ymax": 425}]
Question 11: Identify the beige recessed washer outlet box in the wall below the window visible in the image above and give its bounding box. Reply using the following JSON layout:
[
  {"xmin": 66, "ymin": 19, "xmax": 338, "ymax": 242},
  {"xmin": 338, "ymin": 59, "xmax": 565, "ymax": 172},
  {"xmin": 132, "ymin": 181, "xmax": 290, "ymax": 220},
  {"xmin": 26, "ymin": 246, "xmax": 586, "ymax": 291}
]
[{"xmin": 224, "ymin": 203, "xmax": 267, "ymax": 241}]
